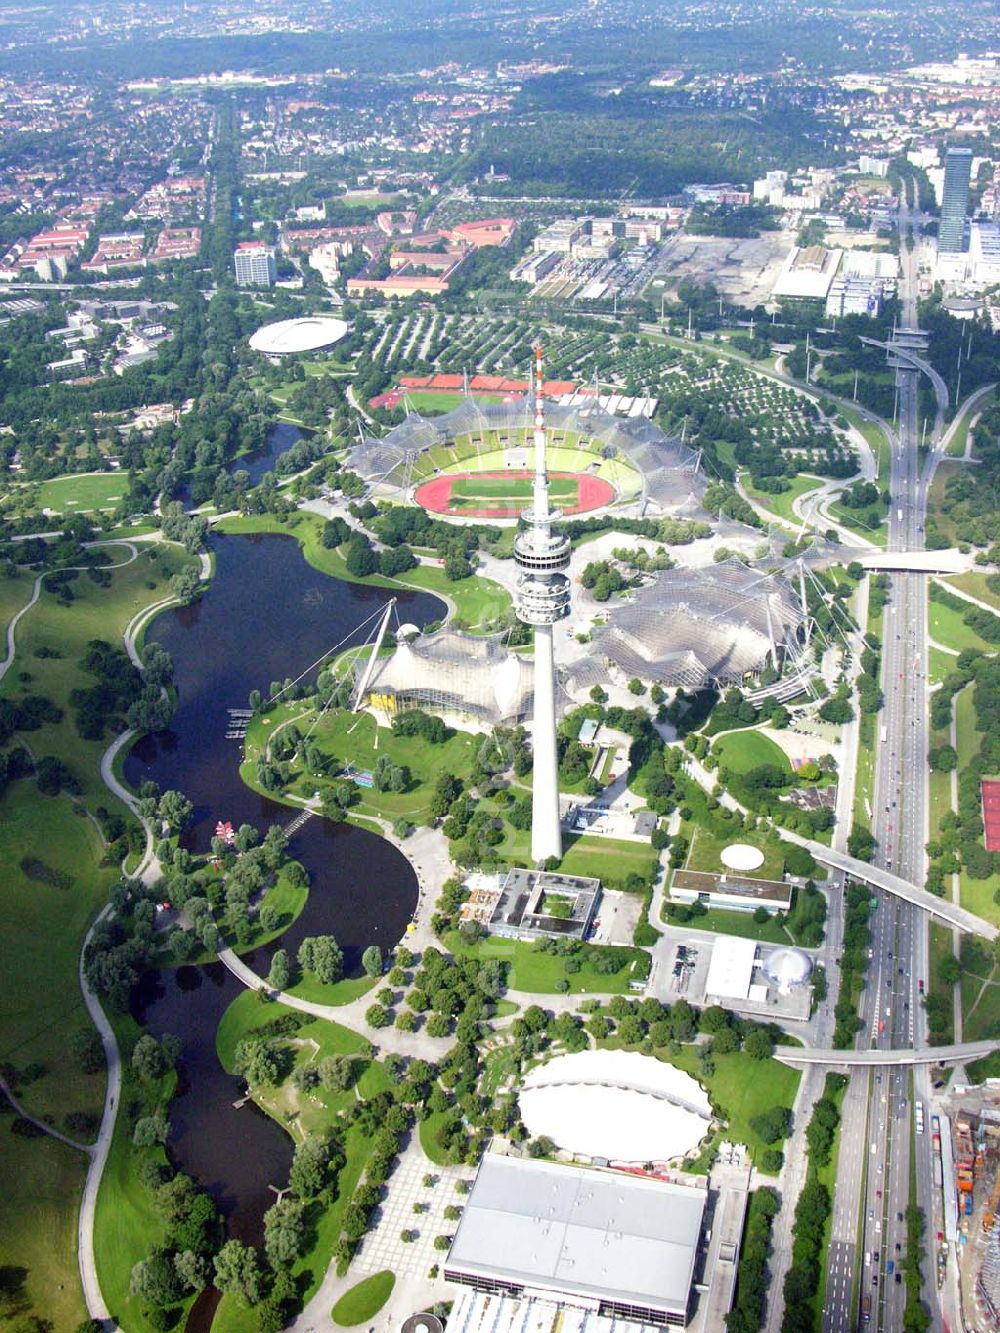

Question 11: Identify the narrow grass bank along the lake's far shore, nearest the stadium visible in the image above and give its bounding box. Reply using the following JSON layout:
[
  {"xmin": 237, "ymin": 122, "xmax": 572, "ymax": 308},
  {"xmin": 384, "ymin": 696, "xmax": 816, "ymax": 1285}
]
[{"xmin": 217, "ymin": 512, "xmax": 511, "ymax": 627}]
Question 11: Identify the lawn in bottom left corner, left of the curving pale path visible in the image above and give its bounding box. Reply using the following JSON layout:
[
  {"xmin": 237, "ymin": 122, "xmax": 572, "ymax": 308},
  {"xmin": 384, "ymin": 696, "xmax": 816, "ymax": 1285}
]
[{"xmin": 0, "ymin": 1125, "xmax": 87, "ymax": 1330}]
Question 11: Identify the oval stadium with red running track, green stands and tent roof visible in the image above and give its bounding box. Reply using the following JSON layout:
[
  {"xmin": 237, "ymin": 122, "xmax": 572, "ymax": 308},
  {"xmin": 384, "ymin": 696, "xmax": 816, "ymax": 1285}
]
[{"xmin": 347, "ymin": 397, "xmax": 707, "ymax": 523}]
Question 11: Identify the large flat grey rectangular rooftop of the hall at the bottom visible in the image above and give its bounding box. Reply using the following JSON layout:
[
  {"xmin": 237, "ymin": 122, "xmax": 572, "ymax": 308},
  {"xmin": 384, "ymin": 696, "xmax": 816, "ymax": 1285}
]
[{"xmin": 447, "ymin": 1156, "xmax": 705, "ymax": 1310}]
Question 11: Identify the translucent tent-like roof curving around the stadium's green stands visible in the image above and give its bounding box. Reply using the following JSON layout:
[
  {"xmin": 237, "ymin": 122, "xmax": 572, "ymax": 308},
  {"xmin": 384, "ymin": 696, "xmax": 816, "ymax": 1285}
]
[{"xmin": 348, "ymin": 396, "xmax": 707, "ymax": 515}]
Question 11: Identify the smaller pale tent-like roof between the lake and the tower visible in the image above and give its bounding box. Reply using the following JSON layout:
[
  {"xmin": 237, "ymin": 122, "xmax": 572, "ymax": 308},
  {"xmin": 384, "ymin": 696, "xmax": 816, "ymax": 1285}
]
[{"xmin": 369, "ymin": 628, "xmax": 533, "ymax": 725}]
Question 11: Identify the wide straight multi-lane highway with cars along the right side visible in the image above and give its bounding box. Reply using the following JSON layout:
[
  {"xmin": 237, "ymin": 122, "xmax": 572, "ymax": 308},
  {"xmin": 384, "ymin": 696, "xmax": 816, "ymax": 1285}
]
[{"xmin": 823, "ymin": 208, "xmax": 941, "ymax": 1333}]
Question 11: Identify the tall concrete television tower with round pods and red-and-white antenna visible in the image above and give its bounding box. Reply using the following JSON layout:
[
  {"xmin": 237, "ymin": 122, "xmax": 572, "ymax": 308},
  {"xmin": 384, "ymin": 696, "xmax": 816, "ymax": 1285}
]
[{"xmin": 513, "ymin": 345, "xmax": 569, "ymax": 865}]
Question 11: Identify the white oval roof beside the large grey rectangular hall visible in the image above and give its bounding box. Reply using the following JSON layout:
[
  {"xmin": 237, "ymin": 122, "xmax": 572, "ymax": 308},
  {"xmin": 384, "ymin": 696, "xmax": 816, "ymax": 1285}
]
[{"xmin": 519, "ymin": 1050, "xmax": 712, "ymax": 1162}]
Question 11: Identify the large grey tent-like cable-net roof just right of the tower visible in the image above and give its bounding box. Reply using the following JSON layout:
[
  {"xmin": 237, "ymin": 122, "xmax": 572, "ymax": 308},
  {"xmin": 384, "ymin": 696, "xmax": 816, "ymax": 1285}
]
[{"xmin": 593, "ymin": 560, "xmax": 807, "ymax": 688}]
